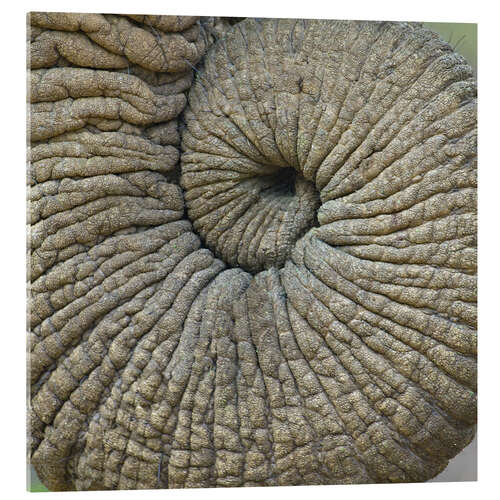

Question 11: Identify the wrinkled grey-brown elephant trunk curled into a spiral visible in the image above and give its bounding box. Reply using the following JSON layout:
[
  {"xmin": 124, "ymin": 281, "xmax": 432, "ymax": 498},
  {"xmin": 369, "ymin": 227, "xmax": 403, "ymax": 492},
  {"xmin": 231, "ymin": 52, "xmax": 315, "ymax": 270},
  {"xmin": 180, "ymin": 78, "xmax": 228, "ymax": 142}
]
[{"xmin": 29, "ymin": 13, "xmax": 477, "ymax": 490}]
